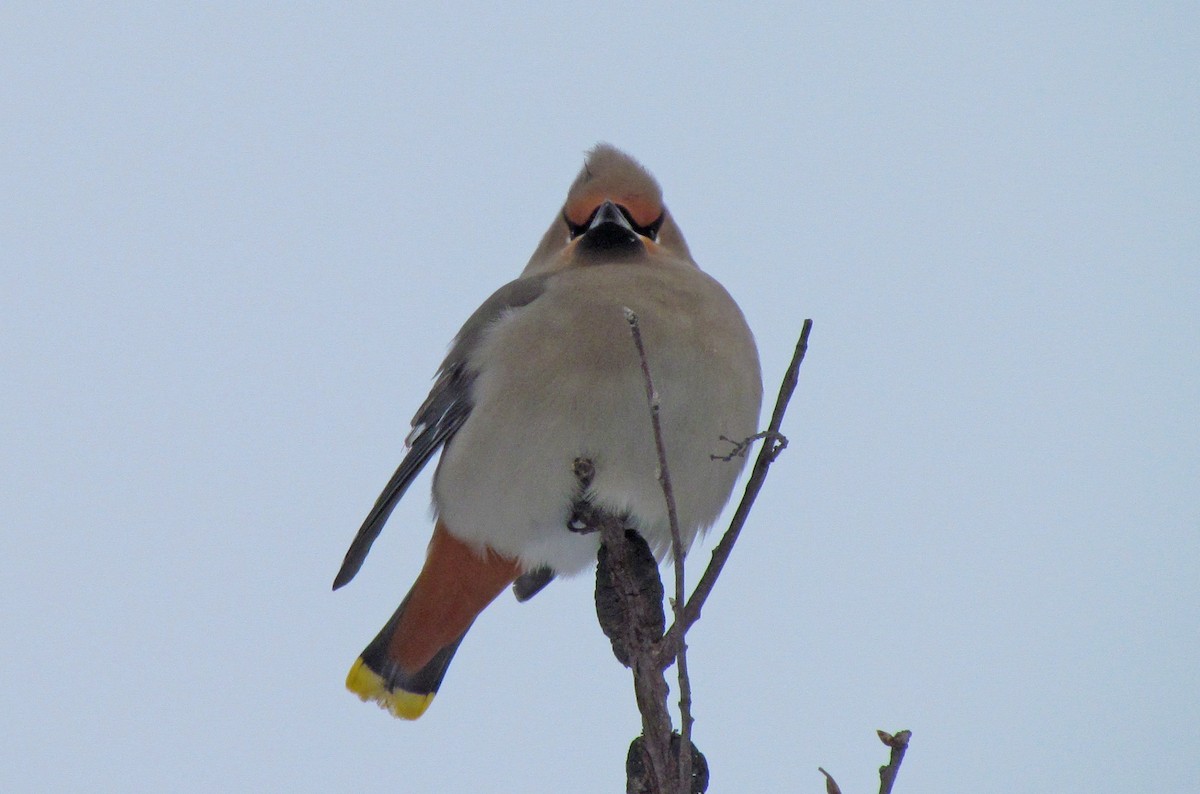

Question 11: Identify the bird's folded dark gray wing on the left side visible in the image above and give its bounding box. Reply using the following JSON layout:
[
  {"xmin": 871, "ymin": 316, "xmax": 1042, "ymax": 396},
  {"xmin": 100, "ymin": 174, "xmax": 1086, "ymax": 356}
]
[{"xmin": 334, "ymin": 276, "xmax": 547, "ymax": 590}]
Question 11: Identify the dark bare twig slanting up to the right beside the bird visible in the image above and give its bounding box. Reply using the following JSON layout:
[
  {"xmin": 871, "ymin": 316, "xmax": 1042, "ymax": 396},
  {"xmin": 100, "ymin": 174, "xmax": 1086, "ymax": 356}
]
[{"xmin": 660, "ymin": 319, "xmax": 812, "ymax": 658}]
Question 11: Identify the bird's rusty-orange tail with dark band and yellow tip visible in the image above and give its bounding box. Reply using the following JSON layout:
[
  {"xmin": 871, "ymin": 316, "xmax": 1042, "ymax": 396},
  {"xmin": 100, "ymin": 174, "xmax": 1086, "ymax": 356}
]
[{"xmin": 346, "ymin": 521, "xmax": 521, "ymax": 720}]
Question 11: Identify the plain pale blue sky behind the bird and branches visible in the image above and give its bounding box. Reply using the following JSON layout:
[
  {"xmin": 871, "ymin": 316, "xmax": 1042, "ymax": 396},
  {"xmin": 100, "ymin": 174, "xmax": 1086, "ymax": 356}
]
[{"xmin": 0, "ymin": 2, "xmax": 1200, "ymax": 793}]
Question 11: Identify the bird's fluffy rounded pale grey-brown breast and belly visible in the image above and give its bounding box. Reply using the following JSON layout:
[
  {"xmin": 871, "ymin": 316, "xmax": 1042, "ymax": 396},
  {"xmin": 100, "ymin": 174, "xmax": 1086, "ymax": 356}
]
[{"xmin": 434, "ymin": 267, "xmax": 760, "ymax": 573}]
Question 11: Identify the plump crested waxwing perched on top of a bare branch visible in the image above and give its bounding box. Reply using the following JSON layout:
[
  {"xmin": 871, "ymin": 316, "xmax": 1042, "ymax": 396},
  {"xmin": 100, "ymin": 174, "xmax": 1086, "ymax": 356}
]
[{"xmin": 334, "ymin": 143, "xmax": 762, "ymax": 720}]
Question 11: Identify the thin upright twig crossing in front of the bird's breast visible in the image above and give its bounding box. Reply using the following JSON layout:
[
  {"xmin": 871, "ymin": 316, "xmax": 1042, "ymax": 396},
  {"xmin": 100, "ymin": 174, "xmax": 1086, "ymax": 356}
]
[{"xmin": 625, "ymin": 308, "xmax": 695, "ymax": 794}]
